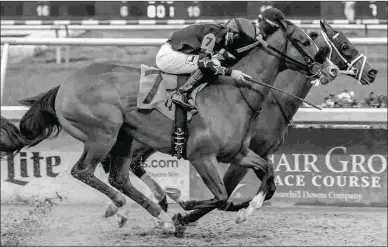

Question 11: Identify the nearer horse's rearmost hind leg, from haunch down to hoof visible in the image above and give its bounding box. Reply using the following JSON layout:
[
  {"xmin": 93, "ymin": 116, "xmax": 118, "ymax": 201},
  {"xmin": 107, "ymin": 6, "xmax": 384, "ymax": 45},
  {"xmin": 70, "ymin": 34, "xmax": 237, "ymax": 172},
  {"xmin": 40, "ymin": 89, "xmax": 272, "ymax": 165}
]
[{"xmin": 56, "ymin": 100, "xmax": 125, "ymax": 214}]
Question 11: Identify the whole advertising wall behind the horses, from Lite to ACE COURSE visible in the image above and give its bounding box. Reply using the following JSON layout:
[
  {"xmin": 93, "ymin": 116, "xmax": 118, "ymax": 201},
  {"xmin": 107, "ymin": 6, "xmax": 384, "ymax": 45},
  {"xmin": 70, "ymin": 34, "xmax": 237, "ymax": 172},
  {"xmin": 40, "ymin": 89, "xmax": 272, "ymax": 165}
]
[{"xmin": 1, "ymin": 128, "xmax": 387, "ymax": 206}]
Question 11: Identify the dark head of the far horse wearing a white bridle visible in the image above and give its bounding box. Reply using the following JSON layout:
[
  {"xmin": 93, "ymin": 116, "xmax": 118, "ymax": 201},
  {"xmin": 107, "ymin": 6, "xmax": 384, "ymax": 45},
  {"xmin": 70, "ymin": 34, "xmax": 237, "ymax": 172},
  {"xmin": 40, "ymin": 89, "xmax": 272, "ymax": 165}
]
[{"xmin": 310, "ymin": 20, "xmax": 377, "ymax": 85}]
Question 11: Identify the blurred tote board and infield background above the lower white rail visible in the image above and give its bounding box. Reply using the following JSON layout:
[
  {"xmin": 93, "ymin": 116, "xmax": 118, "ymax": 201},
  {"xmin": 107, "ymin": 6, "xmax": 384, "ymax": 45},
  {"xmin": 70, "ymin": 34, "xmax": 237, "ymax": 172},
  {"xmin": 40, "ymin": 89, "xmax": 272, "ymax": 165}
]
[{"xmin": 1, "ymin": 1, "xmax": 387, "ymax": 107}]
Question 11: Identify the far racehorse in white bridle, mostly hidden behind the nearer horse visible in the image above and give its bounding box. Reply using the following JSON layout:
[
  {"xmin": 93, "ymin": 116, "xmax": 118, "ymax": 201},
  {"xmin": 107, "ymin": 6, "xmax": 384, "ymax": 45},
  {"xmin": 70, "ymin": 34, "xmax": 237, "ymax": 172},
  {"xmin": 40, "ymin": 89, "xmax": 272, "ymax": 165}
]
[{"xmin": 108, "ymin": 21, "xmax": 377, "ymax": 233}]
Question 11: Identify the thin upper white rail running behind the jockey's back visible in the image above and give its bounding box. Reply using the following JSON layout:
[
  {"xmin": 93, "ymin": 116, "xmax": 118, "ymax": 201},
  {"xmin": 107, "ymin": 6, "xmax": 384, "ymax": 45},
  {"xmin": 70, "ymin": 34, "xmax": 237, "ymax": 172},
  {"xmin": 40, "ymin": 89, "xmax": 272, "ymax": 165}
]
[{"xmin": 1, "ymin": 37, "xmax": 387, "ymax": 46}]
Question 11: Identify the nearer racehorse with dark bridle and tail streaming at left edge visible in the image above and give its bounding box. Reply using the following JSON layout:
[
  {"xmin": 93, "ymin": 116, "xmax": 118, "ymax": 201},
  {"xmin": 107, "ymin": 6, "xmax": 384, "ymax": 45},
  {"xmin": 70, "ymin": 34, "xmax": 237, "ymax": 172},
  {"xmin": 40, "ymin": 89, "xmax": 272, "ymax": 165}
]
[{"xmin": 0, "ymin": 18, "xmax": 336, "ymax": 232}]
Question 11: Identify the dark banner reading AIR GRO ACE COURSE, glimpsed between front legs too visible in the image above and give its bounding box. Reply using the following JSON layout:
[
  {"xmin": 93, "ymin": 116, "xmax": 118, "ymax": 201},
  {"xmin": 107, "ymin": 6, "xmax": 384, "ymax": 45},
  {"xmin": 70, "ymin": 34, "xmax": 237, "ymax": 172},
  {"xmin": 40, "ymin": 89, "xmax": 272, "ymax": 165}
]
[{"xmin": 191, "ymin": 129, "xmax": 387, "ymax": 206}]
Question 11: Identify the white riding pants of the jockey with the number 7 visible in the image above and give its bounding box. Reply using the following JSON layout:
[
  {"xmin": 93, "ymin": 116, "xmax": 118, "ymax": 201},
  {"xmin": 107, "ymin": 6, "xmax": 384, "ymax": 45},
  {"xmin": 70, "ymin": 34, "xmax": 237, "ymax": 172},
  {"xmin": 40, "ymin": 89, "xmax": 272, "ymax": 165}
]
[{"xmin": 156, "ymin": 43, "xmax": 199, "ymax": 74}]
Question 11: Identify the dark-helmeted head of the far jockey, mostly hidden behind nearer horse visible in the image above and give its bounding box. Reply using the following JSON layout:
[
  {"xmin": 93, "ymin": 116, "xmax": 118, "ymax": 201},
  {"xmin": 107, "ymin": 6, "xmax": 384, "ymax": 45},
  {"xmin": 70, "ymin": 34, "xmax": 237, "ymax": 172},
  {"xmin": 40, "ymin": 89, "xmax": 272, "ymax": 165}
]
[{"xmin": 258, "ymin": 8, "xmax": 286, "ymax": 35}]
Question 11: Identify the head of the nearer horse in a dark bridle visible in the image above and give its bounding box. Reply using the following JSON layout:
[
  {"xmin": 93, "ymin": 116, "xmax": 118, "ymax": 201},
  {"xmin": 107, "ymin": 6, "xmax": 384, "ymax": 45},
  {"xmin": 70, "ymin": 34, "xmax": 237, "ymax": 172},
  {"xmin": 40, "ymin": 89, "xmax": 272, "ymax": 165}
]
[{"xmin": 265, "ymin": 20, "xmax": 338, "ymax": 80}]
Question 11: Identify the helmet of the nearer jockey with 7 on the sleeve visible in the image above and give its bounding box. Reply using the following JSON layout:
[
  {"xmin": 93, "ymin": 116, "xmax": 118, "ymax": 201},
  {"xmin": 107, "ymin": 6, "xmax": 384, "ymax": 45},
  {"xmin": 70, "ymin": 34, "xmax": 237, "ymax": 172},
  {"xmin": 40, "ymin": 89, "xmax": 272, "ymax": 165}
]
[{"xmin": 225, "ymin": 18, "xmax": 256, "ymax": 43}]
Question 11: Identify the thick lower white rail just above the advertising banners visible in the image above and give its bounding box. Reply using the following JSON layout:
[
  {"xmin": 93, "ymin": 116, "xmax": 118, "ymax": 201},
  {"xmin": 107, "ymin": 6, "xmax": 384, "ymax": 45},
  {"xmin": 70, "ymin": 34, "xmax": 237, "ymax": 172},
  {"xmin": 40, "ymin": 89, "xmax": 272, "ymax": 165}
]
[{"xmin": 1, "ymin": 106, "xmax": 388, "ymax": 126}]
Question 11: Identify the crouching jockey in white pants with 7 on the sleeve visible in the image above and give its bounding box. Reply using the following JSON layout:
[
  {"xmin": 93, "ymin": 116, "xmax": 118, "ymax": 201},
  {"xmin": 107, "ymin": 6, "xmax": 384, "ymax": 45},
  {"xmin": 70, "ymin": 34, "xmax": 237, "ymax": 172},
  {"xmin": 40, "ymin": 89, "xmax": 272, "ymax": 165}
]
[{"xmin": 156, "ymin": 18, "xmax": 256, "ymax": 109}]
